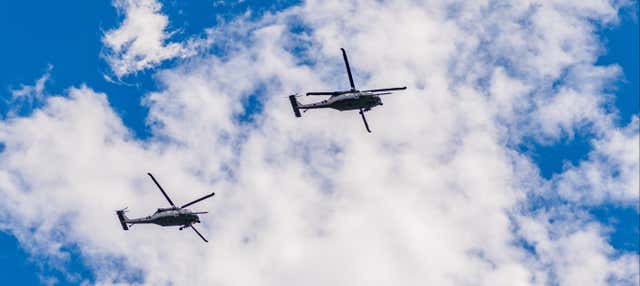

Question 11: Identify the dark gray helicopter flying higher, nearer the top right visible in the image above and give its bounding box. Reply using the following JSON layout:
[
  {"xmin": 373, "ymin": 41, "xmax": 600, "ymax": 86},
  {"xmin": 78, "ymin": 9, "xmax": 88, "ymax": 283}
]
[{"xmin": 289, "ymin": 48, "xmax": 407, "ymax": 133}]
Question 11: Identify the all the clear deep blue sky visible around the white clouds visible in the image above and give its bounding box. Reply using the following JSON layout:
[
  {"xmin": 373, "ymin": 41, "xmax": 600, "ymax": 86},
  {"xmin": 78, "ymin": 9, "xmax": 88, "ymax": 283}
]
[{"xmin": 0, "ymin": 1, "xmax": 640, "ymax": 285}]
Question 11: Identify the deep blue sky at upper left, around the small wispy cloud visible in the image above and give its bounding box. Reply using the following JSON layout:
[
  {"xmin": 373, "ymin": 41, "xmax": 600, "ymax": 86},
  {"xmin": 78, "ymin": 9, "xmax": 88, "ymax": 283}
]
[{"xmin": 0, "ymin": 1, "xmax": 296, "ymax": 138}]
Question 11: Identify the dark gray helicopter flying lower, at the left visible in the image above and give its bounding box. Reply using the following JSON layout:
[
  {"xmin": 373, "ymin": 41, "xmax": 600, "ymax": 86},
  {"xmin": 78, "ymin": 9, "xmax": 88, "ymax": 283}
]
[{"xmin": 116, "ymin": 173, "xmax": 215, "ymax": 242}]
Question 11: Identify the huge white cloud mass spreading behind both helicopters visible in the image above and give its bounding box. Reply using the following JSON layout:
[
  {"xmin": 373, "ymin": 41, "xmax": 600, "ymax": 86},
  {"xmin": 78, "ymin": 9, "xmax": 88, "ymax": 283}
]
[{"xmin": 0, "ymin": 1, "xmax": 638, "ymax": 285}]
